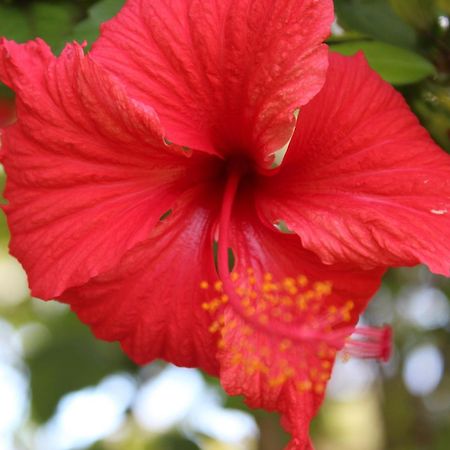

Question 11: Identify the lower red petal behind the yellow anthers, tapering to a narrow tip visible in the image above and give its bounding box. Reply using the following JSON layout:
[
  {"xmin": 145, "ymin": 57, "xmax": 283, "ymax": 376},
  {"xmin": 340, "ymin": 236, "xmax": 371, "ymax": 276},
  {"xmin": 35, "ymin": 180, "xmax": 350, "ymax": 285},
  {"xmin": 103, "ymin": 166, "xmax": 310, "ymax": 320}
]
[{"xmin": 213, "ymin": 204, "xmax": 381, "ymax": 450}]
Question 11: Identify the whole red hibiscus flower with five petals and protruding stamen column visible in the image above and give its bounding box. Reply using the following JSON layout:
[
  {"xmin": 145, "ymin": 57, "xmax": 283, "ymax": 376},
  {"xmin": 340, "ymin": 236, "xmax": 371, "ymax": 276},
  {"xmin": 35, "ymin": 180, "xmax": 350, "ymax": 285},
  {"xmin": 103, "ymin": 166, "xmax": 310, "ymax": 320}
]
[{"xmin": 0, "ymin": 0, "xmax": 450, "ymax": 450}]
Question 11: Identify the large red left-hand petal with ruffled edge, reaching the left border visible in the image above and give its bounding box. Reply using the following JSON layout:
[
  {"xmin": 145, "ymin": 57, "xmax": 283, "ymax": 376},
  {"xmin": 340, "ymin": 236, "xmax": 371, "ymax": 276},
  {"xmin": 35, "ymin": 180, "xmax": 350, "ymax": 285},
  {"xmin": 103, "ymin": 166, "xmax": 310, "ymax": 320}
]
[{"xmin": 0, "ymin": 39, "xmax": 203, "ymax": 298}]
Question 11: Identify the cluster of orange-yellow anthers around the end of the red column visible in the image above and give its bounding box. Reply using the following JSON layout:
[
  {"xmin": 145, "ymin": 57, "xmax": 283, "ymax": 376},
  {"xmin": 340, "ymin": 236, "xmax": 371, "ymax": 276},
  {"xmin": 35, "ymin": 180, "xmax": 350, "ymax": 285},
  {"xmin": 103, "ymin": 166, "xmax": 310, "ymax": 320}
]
[{"xmin": 200, "ymin": 267, "xmax": 355, "ymax": 394}]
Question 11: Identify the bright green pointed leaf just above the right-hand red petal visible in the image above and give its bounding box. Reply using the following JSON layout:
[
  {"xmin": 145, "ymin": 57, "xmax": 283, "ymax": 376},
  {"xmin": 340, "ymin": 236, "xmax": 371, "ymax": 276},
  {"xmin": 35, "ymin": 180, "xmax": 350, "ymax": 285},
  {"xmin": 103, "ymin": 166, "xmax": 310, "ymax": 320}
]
[{"xmin": 331, "ymin": 41, "xmax": 435, "ymax": 85}]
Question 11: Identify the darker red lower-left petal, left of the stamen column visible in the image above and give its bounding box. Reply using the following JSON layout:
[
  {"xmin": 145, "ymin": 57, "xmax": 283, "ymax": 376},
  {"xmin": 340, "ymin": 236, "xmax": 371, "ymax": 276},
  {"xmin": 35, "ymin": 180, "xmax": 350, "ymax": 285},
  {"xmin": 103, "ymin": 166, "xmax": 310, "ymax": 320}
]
[{"xmin": 59, "ymin": 185, "xmax": 221, "ymax": 373}]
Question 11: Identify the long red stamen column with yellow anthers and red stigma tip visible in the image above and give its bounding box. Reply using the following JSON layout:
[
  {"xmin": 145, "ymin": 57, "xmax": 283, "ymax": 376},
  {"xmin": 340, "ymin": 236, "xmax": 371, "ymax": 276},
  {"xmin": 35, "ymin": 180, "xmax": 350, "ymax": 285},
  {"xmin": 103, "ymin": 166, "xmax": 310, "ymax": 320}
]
[{"xmin": 200, "ymin": 164, "xmax": 391, "ymax": 394}]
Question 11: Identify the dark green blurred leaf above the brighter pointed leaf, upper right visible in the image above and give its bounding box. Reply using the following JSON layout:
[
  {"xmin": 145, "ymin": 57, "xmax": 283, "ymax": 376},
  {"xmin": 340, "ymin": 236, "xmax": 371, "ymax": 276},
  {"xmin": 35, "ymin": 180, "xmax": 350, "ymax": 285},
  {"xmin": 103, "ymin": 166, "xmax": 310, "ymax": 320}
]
[{"xmin": 334, "ymin": 0, "xmax": 416, "ymax": 48}]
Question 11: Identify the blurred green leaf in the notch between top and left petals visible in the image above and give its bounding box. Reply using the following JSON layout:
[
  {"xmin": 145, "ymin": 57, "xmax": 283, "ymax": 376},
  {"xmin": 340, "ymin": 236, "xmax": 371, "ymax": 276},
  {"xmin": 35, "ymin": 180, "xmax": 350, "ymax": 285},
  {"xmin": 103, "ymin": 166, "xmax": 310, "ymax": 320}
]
[{"xmin": 71, "ymin": 0, "xmax": 124, "ymax": 48}]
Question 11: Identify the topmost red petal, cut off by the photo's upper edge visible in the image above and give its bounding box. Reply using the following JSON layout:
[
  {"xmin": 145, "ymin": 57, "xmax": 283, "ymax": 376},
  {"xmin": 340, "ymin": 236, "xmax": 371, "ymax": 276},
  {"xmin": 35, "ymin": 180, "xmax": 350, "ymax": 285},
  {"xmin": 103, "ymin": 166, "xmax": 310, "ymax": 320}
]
[{"xmin": 91, "ymin": 0, "xmax": 333, "ymax": 162}]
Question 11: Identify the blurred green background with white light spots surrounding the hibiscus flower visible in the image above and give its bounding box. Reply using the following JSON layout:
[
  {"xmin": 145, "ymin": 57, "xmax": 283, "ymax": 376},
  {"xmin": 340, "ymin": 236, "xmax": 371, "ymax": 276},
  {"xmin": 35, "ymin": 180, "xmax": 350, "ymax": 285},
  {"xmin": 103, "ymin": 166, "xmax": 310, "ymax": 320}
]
[{"xmin": 0, "ymin": 0, "xmax": 450, "ymax": 450}]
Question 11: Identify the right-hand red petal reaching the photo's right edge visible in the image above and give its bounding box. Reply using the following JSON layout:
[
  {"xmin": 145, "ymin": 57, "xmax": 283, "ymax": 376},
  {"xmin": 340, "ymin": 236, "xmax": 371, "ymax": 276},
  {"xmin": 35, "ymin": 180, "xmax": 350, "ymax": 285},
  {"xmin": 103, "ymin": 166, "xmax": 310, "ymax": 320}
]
[{"xmin": 259, "ymin": 51, "xmax": 450, "ymax": 275}]
